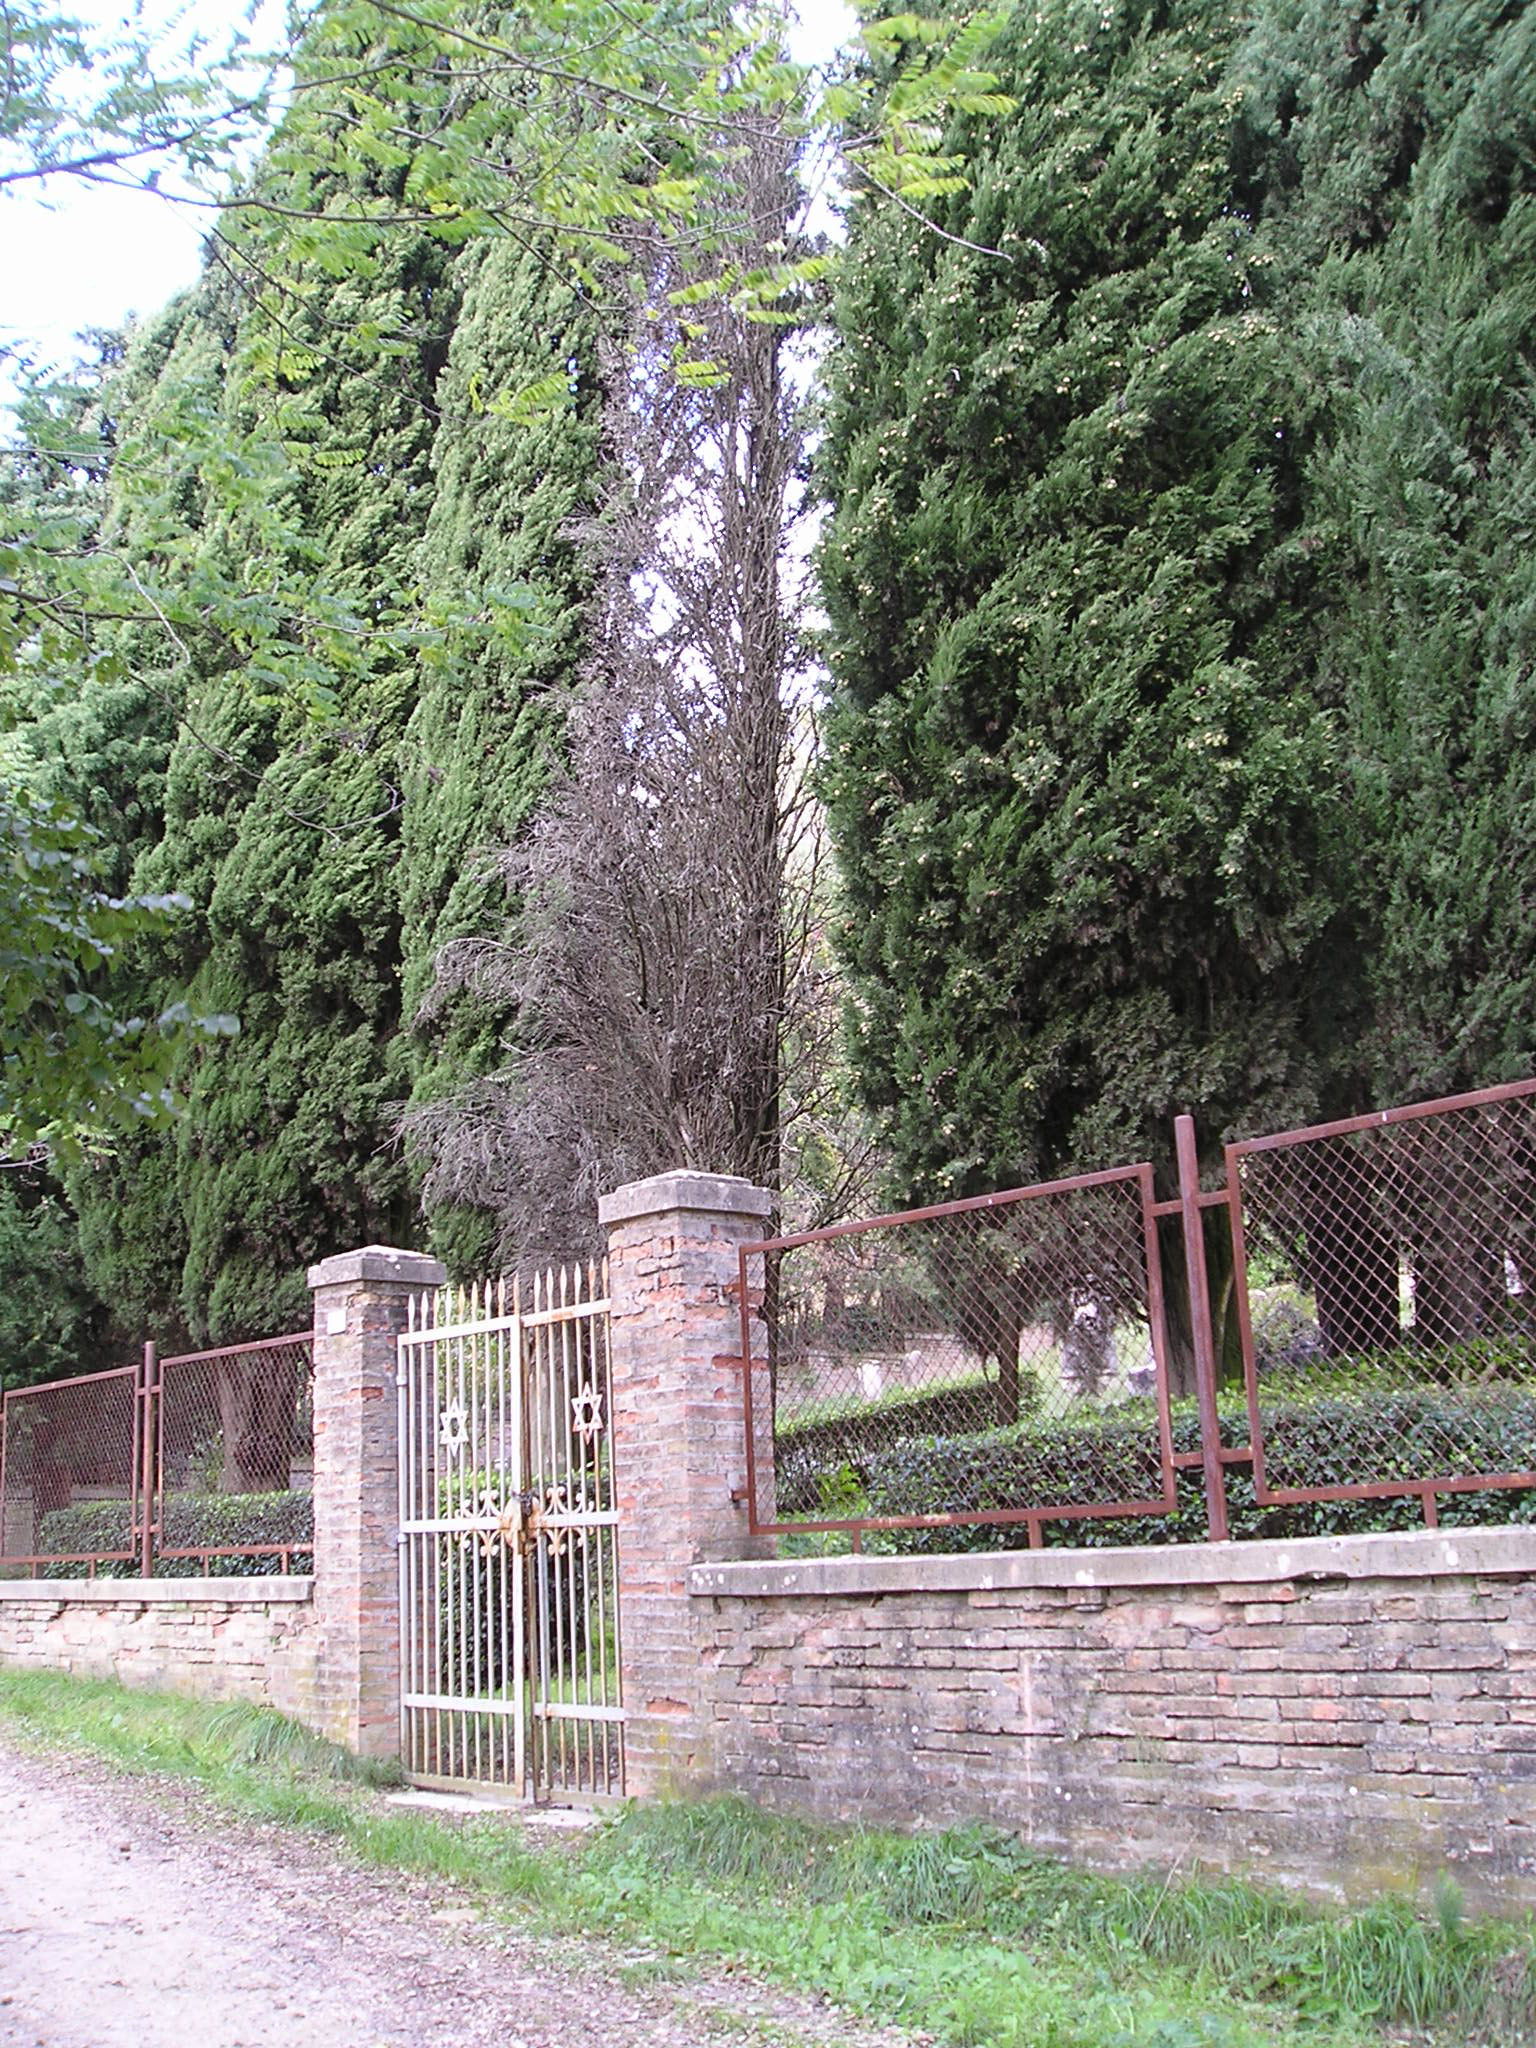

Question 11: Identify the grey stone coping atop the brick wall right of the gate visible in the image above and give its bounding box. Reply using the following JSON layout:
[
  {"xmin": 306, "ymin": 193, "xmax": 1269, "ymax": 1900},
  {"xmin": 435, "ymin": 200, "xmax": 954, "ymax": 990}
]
[{"xmin": 688, "ymin": 1526, "xmax": 1536, "ymax": 1599}]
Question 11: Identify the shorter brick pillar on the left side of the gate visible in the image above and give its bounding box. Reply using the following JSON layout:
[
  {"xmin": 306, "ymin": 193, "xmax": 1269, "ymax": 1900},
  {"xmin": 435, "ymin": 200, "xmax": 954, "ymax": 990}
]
[{"xmin": 309, "ymin": 1245, "xmax": 446, "ymax": 1757}]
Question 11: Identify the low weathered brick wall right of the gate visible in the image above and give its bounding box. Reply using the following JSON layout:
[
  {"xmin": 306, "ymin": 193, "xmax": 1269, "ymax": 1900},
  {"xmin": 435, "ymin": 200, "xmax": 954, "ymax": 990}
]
[{"xmin": 690, "ymin": 1528, "xmax": 1536, "ymax": 1911}]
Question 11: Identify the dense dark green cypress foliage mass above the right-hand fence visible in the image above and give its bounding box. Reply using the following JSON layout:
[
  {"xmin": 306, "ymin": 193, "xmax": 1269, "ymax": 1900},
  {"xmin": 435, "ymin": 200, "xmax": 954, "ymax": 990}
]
[{"xmin": 821, "ymin": 0, "xmax": 1536, "ymax": 1194}]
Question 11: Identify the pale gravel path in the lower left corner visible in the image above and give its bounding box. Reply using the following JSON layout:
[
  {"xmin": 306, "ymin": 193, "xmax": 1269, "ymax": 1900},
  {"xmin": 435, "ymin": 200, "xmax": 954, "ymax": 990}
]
[{"xmin": 0, "ymin": 1735, "xmax": 905, "ymax": 2048}]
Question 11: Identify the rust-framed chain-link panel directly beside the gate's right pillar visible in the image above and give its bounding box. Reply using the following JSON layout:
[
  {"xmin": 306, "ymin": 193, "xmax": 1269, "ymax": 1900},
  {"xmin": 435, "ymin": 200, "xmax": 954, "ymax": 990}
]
[{"xmin": 743, "ymin": 1165, "xmax": 1174, "ymax": 1542}]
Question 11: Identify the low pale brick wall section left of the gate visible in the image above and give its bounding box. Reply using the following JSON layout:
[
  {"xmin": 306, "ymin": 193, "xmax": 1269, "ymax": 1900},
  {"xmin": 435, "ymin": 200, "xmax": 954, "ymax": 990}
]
[{"xmin": 0, "ymin": 1579, "xmax": 317, "ymax": 1726}]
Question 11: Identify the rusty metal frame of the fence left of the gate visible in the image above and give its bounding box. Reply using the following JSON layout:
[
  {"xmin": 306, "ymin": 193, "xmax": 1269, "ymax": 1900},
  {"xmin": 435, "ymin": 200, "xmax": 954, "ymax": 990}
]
[{"xmin": 0, "ymin": 1329, "xmax": 313, "ymax": 1579}]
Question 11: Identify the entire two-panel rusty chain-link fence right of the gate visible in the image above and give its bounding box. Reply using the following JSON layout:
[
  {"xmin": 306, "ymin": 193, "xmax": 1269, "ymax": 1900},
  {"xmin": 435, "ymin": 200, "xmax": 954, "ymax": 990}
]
[{"xmin": 741, "ymin": 1081, "xmax": 1536, "ymax": 1550}]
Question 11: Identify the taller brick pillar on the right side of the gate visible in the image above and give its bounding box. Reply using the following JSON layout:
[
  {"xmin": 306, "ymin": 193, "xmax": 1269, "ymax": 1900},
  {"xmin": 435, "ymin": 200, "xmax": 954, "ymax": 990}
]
[{"xmin": 598, "ymin": 1174, "xmax": 772, "ymax": 1798}]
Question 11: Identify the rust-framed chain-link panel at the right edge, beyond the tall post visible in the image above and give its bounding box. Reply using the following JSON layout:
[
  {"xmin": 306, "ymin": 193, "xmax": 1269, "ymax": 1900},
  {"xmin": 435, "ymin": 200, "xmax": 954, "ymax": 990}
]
[{"xmin": 1227, "ymin": 1083, "xmax": 1536, "ymax": 1520}]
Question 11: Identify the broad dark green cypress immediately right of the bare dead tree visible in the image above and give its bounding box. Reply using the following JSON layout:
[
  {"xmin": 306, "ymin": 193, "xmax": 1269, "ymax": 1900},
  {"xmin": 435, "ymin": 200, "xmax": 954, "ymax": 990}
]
[{"xmin": 821, "ymin": 0, "xmax": 1350, "ymax": 1196}]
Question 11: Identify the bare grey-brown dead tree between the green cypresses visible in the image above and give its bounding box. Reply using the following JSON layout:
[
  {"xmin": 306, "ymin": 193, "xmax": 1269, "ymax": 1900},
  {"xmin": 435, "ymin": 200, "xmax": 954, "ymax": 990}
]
[{"xmin": 408, "ymin": 123, "xmax": 819, "ymax": 1255}]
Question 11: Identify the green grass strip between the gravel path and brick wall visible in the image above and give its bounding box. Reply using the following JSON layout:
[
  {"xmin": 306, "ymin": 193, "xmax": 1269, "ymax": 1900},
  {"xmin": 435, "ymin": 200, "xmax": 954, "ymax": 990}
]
[{"xmin": 0, "ymin": 1671, "xmax": 1536, "ymax": 2048}]
